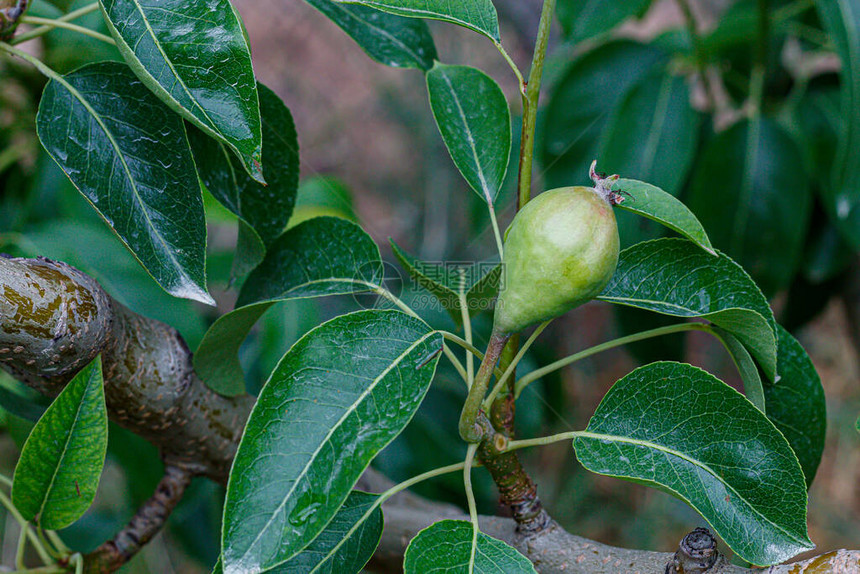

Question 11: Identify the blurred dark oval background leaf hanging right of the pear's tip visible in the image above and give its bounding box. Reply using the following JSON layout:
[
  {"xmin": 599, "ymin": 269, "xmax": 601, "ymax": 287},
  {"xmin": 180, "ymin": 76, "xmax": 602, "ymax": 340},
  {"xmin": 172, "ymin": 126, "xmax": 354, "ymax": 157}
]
[{"xmin": 687, "ymin": 119, "xmax": 812, "ymax": 294}]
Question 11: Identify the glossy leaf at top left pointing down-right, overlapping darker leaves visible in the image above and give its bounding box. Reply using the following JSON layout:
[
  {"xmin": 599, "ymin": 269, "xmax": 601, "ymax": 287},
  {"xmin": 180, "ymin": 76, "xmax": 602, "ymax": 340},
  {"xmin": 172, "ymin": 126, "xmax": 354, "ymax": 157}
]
[{"xmin": 99, "ymin": 0, "xmax": 263, "ymax": 182}]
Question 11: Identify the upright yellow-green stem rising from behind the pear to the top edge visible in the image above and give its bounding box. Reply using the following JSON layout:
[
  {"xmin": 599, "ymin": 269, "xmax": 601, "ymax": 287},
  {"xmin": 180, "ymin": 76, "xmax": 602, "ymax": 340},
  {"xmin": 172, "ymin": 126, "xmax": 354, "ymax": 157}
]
[{"xmin": 517, "ymin": 0, "xmax": 555, "ymax": 209}]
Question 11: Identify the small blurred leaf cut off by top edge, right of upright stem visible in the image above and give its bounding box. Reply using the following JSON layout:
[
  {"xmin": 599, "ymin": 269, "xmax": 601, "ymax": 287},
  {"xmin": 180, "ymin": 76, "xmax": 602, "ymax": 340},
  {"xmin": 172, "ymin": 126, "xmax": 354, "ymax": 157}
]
[{"xmin": 556, "ymin": 0, "xmax": 651, "ymax": 42}]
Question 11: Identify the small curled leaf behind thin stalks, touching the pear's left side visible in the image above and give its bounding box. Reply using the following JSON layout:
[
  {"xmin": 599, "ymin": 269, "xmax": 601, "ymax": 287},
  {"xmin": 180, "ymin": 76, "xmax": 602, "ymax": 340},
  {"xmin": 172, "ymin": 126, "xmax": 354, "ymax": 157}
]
[{"xmin": 389, "ymin": 239, "xmax": 502, "ymax": 324}]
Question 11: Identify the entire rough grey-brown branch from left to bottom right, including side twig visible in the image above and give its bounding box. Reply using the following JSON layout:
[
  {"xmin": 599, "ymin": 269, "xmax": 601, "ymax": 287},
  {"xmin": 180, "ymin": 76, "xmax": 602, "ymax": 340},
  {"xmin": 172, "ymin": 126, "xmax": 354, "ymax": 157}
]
[{"xmin": 0, "ymin": 257, "xmax": 860, "ymax": 574}]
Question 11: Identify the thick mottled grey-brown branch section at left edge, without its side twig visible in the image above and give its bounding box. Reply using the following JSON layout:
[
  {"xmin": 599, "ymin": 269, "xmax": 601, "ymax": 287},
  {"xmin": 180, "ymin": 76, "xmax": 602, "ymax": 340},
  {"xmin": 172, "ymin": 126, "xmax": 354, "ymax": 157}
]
[{"xmin": 0, "ymin": 258, "xmax": 253, "ymax": 484}]
